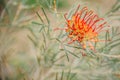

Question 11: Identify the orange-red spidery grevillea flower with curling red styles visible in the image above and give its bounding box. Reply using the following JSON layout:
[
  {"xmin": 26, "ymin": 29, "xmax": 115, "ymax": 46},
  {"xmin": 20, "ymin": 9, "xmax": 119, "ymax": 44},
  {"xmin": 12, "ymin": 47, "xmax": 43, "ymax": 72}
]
[{"xmin": 64, "ymin": 5, "xmax": 107, "ymax": 49}]
